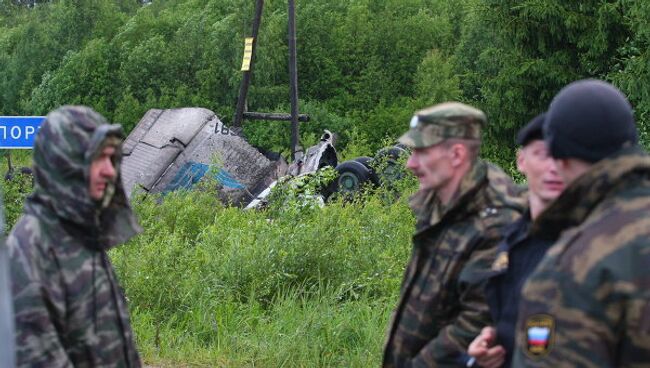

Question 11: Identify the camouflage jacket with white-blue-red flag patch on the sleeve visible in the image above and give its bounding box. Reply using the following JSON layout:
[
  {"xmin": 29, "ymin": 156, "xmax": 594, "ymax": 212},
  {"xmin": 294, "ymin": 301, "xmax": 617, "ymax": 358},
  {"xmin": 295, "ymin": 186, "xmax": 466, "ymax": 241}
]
[{"xmin": 514, "ymin": 148, "xmax": 650, "ymax": 368}]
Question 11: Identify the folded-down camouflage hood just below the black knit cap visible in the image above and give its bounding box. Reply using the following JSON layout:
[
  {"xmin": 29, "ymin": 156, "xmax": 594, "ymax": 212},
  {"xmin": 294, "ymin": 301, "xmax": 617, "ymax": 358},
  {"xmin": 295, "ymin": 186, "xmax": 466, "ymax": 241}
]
[{"xmin": 532, "ymin": 147, "xmax": 650, "ymax": 240}]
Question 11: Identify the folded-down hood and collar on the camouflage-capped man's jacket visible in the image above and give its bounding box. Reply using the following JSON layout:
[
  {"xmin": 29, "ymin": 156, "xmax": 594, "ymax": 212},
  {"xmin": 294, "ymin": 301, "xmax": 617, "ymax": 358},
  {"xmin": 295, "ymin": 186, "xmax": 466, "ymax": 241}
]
[{"xmin": 410, "ymin": 160, "xmax": 526, "ymax": 230}]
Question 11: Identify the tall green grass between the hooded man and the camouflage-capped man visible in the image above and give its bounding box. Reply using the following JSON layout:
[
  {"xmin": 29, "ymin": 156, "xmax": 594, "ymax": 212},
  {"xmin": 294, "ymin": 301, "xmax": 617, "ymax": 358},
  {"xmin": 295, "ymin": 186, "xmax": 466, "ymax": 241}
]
[{"xmin": 111, "ymin": 191, "xmax": 414, "ymax": 367}]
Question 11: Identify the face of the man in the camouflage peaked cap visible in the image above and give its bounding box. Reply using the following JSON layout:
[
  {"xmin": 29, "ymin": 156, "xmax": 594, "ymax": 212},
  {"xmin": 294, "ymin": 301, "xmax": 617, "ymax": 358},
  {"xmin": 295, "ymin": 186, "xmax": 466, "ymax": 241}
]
[{"xmin": 406, "ymin": 144, "xmax": 454, "ymax": 190}]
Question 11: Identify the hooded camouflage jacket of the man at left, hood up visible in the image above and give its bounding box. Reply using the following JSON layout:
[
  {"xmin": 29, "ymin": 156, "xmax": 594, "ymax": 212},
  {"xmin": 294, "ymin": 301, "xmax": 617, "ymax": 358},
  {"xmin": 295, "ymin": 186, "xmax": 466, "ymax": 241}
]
[{"xmin": 7, "ymin": 106, "xmax": 141, "ymax": 367}]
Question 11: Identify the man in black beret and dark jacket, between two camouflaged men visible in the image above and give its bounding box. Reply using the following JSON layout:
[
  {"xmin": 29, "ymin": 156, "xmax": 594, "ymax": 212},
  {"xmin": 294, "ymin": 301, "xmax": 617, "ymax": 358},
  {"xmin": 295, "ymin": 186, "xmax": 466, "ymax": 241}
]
[{"xmin": 468, "ymin": 113, "xmax": 564, "ymax": 368}]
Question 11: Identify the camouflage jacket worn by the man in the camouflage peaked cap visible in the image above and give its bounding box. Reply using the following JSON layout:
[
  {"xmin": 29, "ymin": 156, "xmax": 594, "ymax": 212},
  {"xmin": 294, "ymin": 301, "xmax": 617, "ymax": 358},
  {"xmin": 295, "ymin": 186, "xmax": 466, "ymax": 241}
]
[{"xmin": 383, "ymin": 161, "xmax": 525, "ymax": 367}]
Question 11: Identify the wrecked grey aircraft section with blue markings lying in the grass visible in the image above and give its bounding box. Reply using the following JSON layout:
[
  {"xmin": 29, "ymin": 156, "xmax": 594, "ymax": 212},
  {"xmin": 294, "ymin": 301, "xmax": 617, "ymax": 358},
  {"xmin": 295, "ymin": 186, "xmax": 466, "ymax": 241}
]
[{"xmin": 122, "ymin": 108, "xmax": 337, "ymax": 206}]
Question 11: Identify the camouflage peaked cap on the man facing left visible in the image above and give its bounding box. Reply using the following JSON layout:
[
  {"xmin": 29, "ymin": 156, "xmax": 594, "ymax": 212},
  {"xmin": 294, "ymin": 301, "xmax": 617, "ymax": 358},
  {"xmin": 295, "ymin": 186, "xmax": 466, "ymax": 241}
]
[{"xmin": 399, "ymin": 102, "xmax": 487, "ymax": 148}]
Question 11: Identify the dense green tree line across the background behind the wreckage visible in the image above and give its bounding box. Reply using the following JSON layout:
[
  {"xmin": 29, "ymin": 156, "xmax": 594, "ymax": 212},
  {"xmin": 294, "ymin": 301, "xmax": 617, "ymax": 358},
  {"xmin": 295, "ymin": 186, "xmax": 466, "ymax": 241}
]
[{"xmin": 0, "ymin": 0, "xmax": 650, "ymax": 161}]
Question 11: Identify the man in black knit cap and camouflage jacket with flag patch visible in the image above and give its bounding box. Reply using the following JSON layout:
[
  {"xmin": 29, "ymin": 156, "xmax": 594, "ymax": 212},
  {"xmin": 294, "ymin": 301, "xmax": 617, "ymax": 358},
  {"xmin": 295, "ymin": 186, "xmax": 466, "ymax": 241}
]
[{"xmin": 513, "ymin": 80, "xmax": 650, "ymax": 368}]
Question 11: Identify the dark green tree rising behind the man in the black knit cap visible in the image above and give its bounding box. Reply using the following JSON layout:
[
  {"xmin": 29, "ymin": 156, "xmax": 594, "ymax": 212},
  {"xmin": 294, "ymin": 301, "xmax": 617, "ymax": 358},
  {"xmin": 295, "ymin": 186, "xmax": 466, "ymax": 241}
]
[{"xmin": 459, "ymin": 0, "xmax": 630, "ymax": 138}]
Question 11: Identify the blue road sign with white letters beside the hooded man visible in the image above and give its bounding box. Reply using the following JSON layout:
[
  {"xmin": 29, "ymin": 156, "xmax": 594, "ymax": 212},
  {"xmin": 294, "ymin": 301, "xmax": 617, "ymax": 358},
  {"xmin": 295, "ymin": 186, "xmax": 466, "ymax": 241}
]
[{"xmin": 0, "ymin": 116, "xmax": 45, "ymax": 149}]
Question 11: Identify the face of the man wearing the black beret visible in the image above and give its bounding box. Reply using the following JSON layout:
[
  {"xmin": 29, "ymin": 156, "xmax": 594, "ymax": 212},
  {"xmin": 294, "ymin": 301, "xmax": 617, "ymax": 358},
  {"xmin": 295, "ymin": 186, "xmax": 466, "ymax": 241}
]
[{"xmin": 517, "ymin": 140, "xmax": 564, "ymax": 204}]
